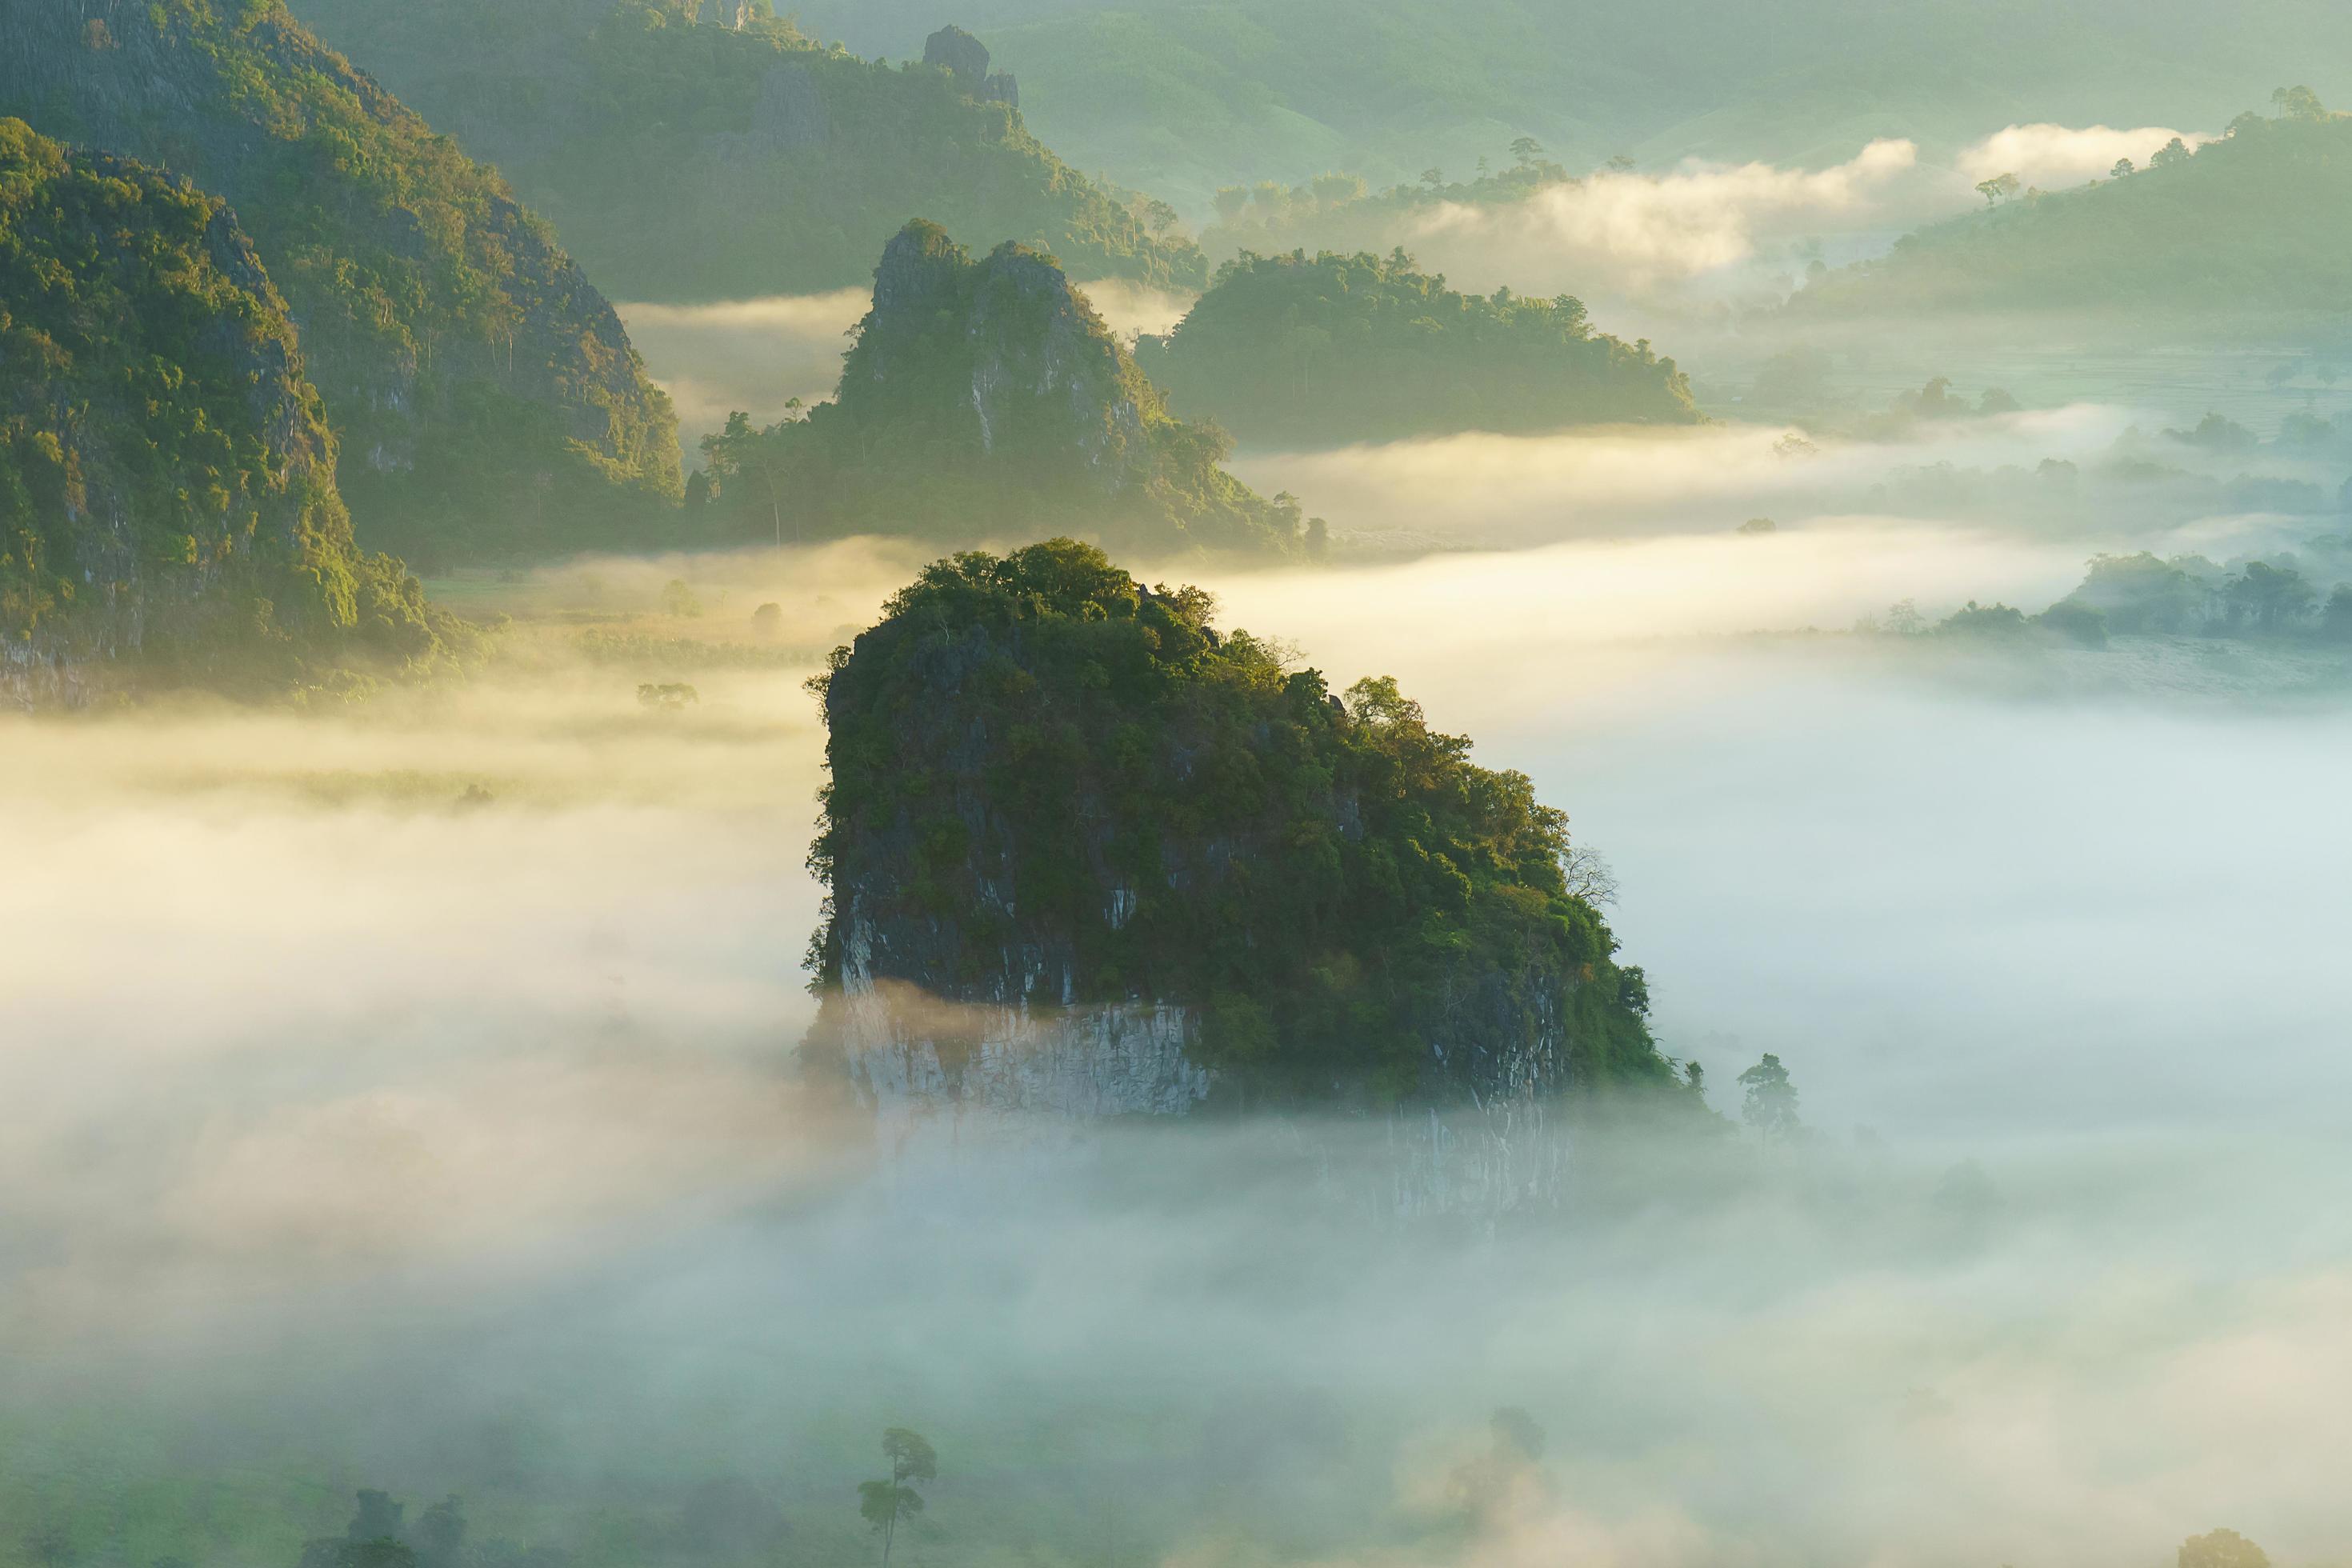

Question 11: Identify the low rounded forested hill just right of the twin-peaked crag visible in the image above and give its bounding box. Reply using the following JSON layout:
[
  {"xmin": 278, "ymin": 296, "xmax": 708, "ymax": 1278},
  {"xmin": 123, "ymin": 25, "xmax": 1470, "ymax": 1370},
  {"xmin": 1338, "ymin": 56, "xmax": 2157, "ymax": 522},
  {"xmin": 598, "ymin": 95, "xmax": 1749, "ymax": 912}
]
[{"xmin": 1136, "ymin": 249, "xmax": 1701, "ymax": 442}]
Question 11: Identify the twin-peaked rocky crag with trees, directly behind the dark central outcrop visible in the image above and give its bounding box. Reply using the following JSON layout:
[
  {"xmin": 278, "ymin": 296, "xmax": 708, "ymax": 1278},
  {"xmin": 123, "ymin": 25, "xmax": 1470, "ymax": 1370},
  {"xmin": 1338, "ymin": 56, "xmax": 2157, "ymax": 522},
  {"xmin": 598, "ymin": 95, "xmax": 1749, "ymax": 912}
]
[{"xmin": 689, "ymin": 221, "xmax": 1301, "ymax": 553}]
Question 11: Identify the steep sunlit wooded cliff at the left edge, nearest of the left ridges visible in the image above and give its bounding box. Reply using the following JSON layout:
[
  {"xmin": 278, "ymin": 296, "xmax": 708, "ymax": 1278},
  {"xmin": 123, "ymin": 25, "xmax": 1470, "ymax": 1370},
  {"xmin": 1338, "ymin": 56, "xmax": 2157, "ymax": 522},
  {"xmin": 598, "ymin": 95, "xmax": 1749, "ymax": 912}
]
[{"xmin": 0, "ymin": 120, "xmax": 463, "ymax": 706}]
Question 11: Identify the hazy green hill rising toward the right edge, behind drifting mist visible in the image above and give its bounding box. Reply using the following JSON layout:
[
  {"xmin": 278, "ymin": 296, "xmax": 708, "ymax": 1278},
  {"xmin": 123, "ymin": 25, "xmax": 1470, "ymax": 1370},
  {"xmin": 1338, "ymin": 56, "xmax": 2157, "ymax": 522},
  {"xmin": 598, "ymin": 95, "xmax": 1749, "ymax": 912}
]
[{"xmin": 1790, "ymin": 98, "xmax": 2352, "ymax": 331}]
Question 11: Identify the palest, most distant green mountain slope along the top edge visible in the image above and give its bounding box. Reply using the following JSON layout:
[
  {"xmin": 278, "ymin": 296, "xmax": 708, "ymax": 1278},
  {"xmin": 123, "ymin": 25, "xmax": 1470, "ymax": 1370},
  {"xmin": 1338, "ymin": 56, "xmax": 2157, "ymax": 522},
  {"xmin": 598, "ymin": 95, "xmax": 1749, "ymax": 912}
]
[{"xmin": 795, "ymin": 0, "xmax": 2352, "ymax": 214}]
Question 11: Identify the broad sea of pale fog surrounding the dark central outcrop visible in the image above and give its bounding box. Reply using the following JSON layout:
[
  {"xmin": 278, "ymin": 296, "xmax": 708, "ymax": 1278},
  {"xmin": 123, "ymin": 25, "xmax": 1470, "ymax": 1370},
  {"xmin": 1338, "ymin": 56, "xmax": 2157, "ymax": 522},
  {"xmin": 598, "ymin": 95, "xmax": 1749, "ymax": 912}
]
[{"xmin": 0, "ymin": 409, "xmax": 2352, "ymax": 1568}]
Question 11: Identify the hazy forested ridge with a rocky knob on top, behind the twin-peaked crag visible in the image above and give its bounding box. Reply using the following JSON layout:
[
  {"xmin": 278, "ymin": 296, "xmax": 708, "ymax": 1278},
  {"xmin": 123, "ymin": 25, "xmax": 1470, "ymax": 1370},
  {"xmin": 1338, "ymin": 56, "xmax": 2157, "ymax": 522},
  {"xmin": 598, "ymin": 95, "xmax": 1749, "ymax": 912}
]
[{"xmin": 301, "ymin": 0, "xmax": 1206, "ymax": 301}]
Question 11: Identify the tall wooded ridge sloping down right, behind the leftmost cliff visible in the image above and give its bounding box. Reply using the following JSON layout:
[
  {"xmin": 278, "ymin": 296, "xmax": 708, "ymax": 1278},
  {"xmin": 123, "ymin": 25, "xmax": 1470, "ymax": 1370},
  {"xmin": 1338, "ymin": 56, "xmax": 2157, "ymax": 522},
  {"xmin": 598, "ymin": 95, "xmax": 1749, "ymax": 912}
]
[{"xmin": 0, "ymin": 0, "xmax": 680, "ymax": 559}]
